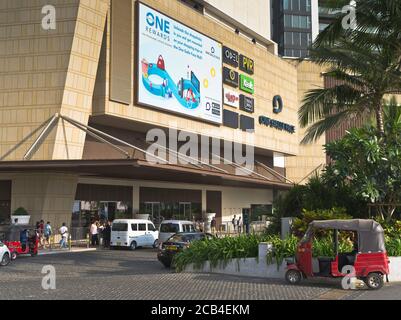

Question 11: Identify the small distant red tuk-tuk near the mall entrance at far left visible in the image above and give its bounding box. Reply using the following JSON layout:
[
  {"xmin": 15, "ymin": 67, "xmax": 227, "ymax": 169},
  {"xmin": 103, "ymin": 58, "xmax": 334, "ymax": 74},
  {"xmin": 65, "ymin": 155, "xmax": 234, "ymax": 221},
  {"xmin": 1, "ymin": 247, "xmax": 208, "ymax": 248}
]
[{"xmin": 0, "ymin": 224, "xmax": 39, "ymax": 260}]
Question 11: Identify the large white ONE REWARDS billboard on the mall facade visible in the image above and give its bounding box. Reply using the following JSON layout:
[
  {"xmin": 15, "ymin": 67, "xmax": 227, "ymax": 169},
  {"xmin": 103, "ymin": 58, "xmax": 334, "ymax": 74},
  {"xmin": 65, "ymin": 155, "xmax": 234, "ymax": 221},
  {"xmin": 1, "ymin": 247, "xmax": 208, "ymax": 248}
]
[{"xmin": 136, "ymin": 3, "xmax": 223, "ymax": 124}]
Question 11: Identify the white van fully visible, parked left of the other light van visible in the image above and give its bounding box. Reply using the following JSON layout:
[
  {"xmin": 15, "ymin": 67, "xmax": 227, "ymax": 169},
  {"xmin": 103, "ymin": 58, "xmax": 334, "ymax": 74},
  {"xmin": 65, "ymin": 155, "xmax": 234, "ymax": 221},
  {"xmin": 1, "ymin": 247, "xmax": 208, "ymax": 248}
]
[{"xmin": 110, "ymin": 219, "xmax": 159, "ymax": 250}]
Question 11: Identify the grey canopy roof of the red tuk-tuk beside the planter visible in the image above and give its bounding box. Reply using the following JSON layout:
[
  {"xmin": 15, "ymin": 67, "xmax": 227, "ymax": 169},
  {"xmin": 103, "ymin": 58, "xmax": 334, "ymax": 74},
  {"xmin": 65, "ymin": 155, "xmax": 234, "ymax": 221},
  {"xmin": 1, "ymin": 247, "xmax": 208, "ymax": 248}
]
[{"xmin": 309, "ymin": 219, "xmax": 386, "ymax": 253}]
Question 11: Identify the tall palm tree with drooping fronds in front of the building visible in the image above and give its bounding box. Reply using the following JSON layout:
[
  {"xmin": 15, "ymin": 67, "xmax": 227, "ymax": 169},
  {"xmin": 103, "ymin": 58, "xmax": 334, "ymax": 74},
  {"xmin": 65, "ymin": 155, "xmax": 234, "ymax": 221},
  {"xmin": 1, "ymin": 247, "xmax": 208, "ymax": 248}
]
[{"xmin": 299, "ymin": 0, "xmax": 401, "ymax": 143}]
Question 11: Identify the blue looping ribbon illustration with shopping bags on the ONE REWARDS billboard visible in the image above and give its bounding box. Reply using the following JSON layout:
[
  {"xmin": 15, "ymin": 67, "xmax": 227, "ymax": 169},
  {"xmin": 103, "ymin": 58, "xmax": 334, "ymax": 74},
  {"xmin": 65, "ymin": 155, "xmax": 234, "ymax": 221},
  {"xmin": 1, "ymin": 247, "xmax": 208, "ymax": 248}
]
[{"xmin": 141, "ymin": 55, "xmax": 200, "ymax": 109}]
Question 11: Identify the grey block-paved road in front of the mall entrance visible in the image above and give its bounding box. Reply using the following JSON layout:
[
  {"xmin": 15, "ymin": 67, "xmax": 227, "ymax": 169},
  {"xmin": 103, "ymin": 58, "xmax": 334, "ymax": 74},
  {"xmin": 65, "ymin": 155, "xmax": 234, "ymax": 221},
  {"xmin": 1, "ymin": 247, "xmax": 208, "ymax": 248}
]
[{"xmin": 0, "ymin": 249, "xmax": 401, "ymax": 300}]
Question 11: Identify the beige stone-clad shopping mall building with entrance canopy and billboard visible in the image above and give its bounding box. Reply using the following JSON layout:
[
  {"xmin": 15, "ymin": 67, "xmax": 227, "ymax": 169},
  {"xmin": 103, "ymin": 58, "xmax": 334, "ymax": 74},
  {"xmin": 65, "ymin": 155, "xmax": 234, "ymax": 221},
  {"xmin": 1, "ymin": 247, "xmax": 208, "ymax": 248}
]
[{"xmin": 0, "ymin": 0, "xmax": 325, "ymax": 235}]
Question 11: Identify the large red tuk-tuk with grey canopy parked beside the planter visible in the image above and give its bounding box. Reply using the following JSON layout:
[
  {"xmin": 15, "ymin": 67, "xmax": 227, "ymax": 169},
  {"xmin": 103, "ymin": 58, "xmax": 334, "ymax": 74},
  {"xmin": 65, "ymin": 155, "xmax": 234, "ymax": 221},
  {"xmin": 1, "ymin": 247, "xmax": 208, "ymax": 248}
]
[{"xmin": 285, "ymin": 219, "xmax": 389, "ymax": 289}]
